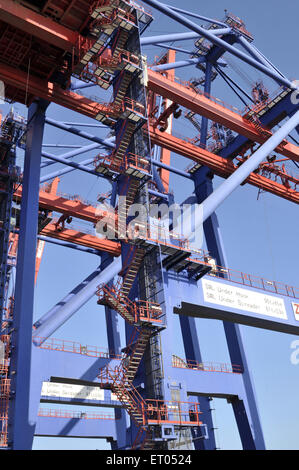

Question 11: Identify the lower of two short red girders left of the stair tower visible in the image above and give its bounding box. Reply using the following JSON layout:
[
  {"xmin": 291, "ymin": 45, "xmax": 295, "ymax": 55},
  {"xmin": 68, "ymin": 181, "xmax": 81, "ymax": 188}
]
[{"xmin": 40, "ymin": 224, "xmax": 121, "ymax": 256}]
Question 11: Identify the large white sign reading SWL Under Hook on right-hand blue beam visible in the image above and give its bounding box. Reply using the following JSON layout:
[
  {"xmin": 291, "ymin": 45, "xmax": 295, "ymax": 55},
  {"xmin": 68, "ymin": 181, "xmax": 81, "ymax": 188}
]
[{"xmin": 202, "ymin": 279, "xmax": 288, "ymax": 320}]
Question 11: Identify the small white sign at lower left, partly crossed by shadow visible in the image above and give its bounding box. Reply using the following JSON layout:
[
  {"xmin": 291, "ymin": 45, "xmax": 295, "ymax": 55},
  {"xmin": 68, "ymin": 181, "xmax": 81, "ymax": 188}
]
[{"xmin": 42, "ymin": 382, "xmax": 104, "ymax": 400}]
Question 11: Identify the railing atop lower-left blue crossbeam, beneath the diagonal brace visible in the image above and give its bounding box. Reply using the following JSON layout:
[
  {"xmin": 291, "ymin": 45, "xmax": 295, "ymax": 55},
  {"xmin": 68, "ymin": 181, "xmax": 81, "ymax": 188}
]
[{"xmin": 35, "ymin": 336, "xmax": 123, "ymax": 360}]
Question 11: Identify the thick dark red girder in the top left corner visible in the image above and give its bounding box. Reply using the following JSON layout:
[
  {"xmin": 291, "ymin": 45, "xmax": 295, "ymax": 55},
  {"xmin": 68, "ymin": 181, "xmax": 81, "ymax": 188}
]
[{"xmin": 0, "ymin": 0, "xmax": 79, "ymax": 52}]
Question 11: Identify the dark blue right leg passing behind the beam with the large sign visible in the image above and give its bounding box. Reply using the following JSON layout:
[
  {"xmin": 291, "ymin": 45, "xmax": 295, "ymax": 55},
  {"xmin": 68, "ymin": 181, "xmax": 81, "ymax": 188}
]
[{"xmin": 195, "ymin": 167, "xmax": 265, "ymax": 450}]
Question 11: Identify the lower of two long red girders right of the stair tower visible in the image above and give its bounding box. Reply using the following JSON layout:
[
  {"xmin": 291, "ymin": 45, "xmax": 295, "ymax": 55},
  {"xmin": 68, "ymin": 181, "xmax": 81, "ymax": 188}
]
[{"xmin": 149, "ymin": 126, "xmax": 299, "ymax": 204}]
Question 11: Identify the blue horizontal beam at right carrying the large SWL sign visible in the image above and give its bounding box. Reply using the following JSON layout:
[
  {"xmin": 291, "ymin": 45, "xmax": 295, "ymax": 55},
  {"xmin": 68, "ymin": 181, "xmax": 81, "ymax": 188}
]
[{"xmin": 174, "ymin": 276, "xmax": 299, "ymax": 335}]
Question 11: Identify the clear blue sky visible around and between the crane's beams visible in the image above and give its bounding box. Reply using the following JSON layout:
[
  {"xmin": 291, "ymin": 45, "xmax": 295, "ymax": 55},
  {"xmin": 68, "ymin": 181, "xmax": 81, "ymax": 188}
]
[{"xmin": 2, "ymin": 0, "xmax": 299, "ymax": 449}]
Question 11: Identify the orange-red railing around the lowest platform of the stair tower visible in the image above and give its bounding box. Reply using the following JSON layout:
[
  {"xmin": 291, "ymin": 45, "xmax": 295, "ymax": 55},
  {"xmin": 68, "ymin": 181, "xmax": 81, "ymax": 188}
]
[{"xmin": 146, "ymin": 400, "xmax": 202, "ymax": 426}]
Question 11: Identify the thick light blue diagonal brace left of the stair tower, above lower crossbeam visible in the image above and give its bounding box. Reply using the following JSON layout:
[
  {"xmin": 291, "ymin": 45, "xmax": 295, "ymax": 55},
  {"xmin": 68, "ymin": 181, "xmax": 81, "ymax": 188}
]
[{"xmin": 33, "ymin": 257, "xmax": 122, "ymax": 345}]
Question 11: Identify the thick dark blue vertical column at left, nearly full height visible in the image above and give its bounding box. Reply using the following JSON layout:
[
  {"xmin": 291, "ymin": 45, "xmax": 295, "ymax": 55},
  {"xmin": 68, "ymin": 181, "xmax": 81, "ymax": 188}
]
[{"xmin": 9, "ymin": 100, "xmax": 48, "ymax": 450}]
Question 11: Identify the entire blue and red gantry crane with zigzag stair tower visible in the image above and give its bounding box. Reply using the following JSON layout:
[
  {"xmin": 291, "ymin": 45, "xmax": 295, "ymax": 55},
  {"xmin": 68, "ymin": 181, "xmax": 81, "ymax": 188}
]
[{"xmin": 0, "ymin": 0, "xmax": 299, "ymax": 450}]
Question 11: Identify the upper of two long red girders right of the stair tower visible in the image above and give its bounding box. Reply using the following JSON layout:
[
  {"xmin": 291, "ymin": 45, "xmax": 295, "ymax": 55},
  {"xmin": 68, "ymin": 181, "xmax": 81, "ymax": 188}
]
[{"xmin": 147, "ymin": 69, "xmax": 299, "ymax": 161}]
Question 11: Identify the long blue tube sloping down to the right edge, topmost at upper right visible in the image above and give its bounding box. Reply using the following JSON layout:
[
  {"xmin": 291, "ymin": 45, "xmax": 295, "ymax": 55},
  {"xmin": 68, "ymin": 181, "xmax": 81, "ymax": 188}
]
[{"xmin": 144, "ymin": 0, "xmax": 296, "ymax": 90}]
